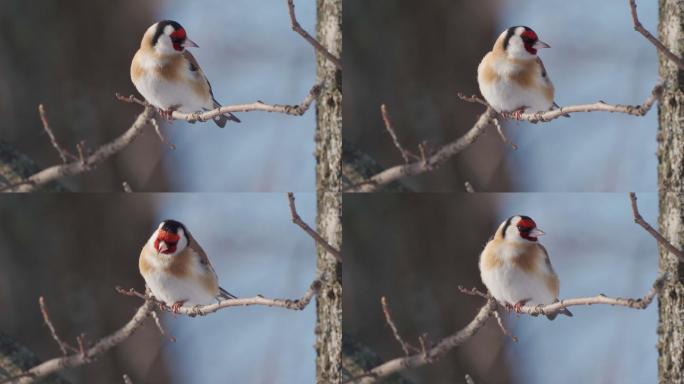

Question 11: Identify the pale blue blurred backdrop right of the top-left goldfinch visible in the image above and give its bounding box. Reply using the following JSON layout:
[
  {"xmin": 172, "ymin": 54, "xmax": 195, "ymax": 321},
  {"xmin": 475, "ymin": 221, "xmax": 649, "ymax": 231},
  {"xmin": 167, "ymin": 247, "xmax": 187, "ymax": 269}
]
[{"xmin": 150, "ymin": 0, "xmax": 316, "ymax": 192}]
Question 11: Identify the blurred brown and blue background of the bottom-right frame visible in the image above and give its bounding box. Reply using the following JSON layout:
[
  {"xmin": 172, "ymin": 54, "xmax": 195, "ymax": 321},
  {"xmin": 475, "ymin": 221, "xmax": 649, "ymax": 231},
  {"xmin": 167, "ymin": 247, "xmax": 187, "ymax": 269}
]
[{"xmin": 343, "ymin": 193, "xmax": 658, "ymax": 384}]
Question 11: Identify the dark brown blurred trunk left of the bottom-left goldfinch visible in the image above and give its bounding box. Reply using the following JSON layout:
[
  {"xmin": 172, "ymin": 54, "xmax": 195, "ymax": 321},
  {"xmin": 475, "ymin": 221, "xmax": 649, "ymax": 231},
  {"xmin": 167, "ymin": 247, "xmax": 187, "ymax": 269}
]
[{"xmin": 0, "ymin": 193, "xmax": 169, "ymax": 383}]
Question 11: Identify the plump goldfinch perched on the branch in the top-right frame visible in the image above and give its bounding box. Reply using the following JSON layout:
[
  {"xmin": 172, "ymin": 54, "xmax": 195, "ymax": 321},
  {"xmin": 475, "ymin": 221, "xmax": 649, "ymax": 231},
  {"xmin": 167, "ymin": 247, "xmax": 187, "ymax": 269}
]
[{"xmin": 477, "ymin": 26, "xmax": 557, "ymax": 119}]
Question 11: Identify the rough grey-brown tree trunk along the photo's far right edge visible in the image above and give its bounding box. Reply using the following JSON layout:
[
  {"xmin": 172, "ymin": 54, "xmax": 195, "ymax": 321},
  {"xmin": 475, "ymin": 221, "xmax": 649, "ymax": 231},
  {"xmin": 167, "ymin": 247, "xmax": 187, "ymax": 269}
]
[{"xmin": 657, "ymin": 0, "xmax": 684, "ymax": 383}]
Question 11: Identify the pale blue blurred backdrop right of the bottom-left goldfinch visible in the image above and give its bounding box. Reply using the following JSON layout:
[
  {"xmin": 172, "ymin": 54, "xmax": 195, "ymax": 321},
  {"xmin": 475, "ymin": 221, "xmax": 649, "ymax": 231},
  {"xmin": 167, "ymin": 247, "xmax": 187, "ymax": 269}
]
[{"xmin": 150, "ymin": 193, "xmax": 316, "ymax": 384}]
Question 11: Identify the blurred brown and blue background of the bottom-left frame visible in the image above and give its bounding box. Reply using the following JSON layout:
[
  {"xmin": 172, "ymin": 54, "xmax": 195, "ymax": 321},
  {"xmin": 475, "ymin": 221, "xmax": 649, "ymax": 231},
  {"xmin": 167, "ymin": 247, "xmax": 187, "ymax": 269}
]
[{"xmin": 0, "ymin": 193, "xmax": 316, "ymax": 383}]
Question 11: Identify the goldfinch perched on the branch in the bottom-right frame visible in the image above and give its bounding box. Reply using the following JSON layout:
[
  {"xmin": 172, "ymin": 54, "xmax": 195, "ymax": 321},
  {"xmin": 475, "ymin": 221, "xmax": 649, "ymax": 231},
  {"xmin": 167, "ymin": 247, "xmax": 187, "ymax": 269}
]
[{"xmin": 480, "ymin": 216, "xmax": 572, "ymax": 320}]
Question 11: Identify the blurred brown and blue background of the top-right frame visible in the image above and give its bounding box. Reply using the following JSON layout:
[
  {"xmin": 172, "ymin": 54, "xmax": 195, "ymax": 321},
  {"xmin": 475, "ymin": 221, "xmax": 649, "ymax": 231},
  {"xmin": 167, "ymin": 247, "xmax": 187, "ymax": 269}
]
[{"xmin": 343, "ymin": 0, "xmax": 657, "ymax": 192}]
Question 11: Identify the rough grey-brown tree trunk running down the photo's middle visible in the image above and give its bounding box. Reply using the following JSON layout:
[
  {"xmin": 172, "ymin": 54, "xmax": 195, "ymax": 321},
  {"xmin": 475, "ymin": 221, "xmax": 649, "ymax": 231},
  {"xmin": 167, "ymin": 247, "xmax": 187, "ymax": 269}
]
[{"xmin": 316, "ymin": 0, "xmax": 342, "ymax": 383}]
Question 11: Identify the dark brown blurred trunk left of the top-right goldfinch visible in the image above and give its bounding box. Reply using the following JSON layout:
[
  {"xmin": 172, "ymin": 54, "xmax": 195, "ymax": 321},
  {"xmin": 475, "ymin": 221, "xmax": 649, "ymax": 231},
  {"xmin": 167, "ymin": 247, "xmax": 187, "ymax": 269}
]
[{"xmin": 343, "ymin": 0, "xmax": 510, "ymax": 191}]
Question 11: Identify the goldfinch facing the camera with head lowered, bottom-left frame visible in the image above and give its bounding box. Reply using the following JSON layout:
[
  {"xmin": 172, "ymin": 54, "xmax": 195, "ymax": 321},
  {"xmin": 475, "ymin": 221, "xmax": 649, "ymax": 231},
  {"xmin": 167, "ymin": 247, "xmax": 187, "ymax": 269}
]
[{"xmin": 138, "ymin": 220, "xmax": 236, "ymax": 312}]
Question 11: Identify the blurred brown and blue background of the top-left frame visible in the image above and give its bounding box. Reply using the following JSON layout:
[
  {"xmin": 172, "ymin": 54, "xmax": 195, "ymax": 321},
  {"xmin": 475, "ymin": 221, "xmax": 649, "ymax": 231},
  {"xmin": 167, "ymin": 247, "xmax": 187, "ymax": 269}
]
[{"xmin": 0, "ymin": 0, "xmax": 315, "ymax": 192}]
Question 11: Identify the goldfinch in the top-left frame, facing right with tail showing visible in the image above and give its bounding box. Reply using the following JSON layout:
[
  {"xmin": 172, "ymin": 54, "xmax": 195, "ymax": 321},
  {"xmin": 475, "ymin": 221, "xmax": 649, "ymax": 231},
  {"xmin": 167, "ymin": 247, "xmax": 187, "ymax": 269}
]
[{"xmin": 131, "ymin": 20, "xmax": 240, "ymax": 128}]
